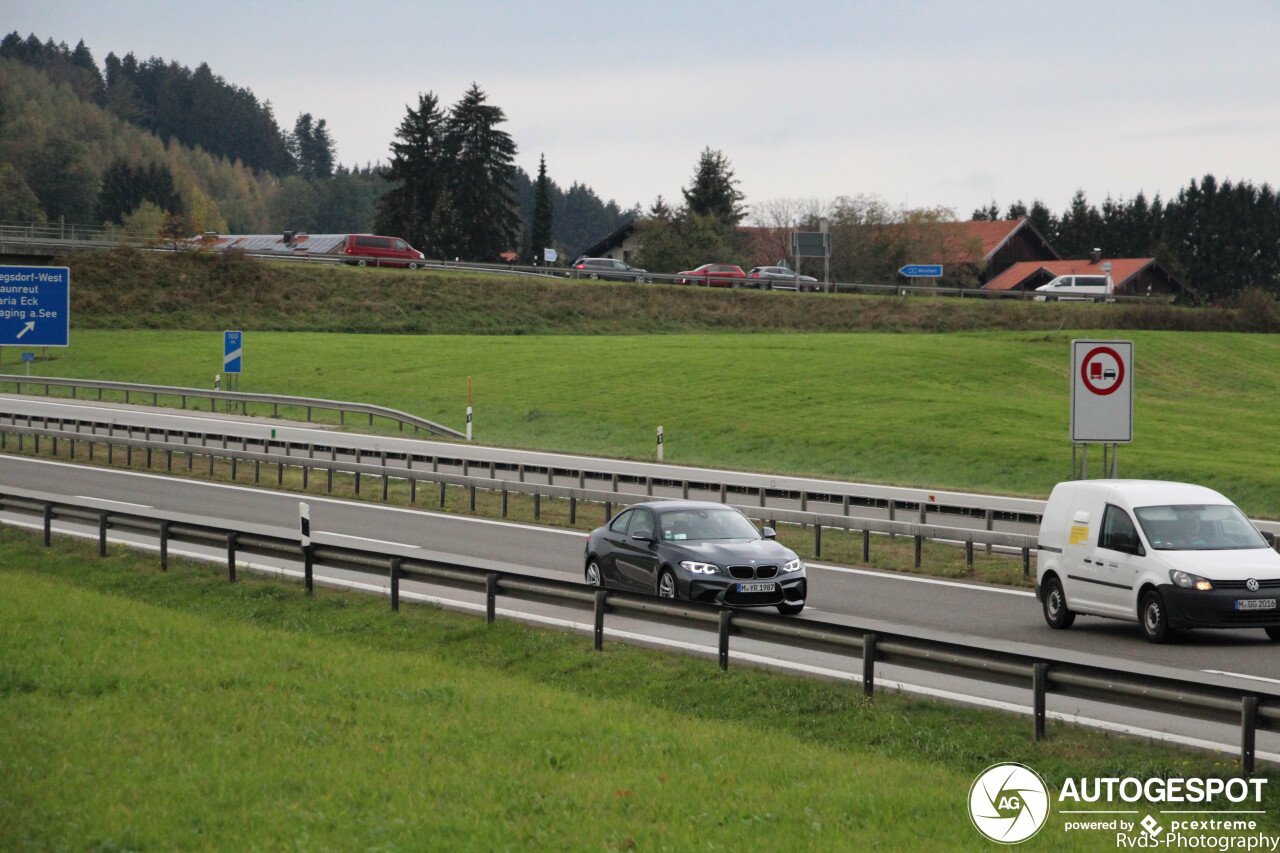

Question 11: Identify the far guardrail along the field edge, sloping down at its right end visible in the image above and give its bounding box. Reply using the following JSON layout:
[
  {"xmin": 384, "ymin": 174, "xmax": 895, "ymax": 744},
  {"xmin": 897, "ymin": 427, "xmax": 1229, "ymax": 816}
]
[{"xmin": 0, "ymin": 374, "xmax": 466, "ymax": 438}]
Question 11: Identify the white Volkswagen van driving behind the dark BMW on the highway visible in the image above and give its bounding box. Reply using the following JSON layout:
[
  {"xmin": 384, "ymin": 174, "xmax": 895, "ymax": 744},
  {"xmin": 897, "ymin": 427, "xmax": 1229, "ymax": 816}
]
[{"xmin": 1036, "ymin": 480, "xmax": 1280, "ymax": 643}]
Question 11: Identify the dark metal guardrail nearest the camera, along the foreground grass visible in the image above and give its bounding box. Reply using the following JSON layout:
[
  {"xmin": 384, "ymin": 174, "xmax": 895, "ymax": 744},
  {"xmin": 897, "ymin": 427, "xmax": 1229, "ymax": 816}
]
[{"xmin": 0, "ymin": 484, "xmax": 1280, "ymax": 776}]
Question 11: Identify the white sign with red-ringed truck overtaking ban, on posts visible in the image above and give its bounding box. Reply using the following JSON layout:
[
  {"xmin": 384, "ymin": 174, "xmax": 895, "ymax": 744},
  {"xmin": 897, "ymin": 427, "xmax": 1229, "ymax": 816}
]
[{"xmin": 1071, "ymin": 341, "xmax": 1133, "ymax": 479}]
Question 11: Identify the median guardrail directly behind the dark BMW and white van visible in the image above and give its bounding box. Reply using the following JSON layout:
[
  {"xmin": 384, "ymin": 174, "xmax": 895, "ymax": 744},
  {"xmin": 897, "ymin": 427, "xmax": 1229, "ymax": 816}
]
[{"xmin": 0, "ymin": 423, "xmax": 1036, "ymax": 576}]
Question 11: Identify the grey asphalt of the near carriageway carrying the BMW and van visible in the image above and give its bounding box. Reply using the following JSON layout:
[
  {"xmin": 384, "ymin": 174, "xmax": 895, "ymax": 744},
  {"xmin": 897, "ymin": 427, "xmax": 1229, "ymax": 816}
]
[{"xmin": 0, "ymin": 456, "xmax": 1280, "ymax": 681}]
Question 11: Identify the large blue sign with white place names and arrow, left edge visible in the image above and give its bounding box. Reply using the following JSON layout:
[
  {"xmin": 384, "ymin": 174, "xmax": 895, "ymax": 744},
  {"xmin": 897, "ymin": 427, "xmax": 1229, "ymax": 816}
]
[{"xmin": 0, "ymin": 266, "xmax": 72, "ymax": 347}]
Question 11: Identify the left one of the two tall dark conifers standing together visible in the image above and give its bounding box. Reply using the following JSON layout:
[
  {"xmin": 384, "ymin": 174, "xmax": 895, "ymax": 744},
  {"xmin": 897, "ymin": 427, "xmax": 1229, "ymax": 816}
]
[{"xmin": 374, "ymin": 92, "xmax": 448, "ymax": 257}]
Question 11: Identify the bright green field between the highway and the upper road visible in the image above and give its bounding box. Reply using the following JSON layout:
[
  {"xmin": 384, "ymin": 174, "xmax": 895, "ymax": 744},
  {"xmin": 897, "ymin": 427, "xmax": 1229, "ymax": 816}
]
[{"xmin": 15, "ymin": 330, "xmax": 1280, "ymax": 517}]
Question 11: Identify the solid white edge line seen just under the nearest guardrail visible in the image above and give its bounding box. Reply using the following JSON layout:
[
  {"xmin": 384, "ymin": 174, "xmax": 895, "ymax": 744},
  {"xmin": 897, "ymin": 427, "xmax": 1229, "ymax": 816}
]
[{"xmin": 5, "ymin": 512, "xmax": 1280, "ymax": 763}]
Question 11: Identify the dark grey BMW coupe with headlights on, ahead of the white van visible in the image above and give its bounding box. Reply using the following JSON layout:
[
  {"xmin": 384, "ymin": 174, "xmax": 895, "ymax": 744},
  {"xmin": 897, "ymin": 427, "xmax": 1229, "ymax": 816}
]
[{"xmin": 584, "ymin": 501, "xmax": 808, "ymax": 613}]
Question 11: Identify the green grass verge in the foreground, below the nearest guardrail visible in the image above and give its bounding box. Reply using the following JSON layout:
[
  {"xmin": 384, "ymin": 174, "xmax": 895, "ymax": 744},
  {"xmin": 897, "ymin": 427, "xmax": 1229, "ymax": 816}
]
[{"xmin": 0, "ymin": 528, "xmax": 1277, "ymax": 850}]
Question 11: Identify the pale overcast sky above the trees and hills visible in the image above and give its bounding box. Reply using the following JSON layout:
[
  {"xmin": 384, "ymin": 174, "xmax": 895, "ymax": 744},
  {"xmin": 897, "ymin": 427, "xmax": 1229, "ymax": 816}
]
[{"xmin": 10, "ymin": 0, "xmax": 1280, "ymax": 218}]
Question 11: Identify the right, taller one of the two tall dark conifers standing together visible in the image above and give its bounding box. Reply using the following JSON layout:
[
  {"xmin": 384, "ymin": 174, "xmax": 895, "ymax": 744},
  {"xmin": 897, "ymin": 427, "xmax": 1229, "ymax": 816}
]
[{"xmin": 444, "ymin": 83, "xmax": 520, "ymax": 261}]
